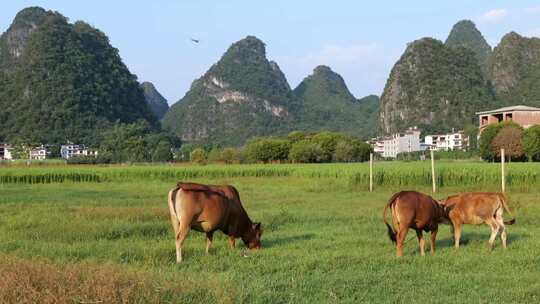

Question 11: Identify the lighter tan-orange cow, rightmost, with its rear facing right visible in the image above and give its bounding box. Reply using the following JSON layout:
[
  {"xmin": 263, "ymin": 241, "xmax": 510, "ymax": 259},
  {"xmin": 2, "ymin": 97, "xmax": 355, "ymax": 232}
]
[{"xmin": 441, "ymin": 192, "xmax": 515, "ymax": 249}]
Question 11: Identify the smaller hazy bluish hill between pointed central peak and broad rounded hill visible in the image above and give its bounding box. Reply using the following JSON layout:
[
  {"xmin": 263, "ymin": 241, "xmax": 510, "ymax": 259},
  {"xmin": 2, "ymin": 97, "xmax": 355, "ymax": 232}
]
[{"xmin": 293, "ymin": 66, "xmax": 378, "ymax": 137}]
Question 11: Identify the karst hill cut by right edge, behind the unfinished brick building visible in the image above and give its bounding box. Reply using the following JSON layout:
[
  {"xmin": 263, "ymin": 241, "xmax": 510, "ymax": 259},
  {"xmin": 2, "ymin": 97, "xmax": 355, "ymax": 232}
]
[{"xmin": 489, "ymin": 32, "xmax": 540, "ymax": 97}]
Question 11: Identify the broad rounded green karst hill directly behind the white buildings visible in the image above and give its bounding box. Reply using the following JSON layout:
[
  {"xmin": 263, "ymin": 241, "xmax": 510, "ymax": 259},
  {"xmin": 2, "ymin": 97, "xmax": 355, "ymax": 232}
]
[{"xmin": 379, "ymin": 38, "xmax": 493, "ymax": 133}]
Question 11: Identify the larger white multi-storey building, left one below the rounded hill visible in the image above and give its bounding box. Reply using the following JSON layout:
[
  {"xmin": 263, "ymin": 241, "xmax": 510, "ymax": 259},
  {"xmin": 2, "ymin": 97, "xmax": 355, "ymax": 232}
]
[{"xmin": 373, "ymin": 127, "xmax": 423, "ymax": 158}]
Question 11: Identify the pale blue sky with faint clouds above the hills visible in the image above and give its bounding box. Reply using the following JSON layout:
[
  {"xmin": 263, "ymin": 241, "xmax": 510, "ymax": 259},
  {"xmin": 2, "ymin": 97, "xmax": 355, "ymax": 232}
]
[{"xmin": 0, "ymin": 0, "xmax": 540, "ymax": 104}]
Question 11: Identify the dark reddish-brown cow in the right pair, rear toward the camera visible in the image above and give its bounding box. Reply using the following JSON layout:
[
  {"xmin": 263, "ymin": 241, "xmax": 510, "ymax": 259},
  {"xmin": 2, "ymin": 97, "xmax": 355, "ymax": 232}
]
[{"xmin": 383, "ymin": 191, "xmax": 445, "ymax": 257}]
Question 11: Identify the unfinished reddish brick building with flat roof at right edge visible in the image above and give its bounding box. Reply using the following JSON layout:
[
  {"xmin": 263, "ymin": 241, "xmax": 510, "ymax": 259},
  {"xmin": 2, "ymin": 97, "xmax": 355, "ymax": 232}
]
[{"xmin": 476, "ymin": 105, "xmax": 540, "ymax": 132}]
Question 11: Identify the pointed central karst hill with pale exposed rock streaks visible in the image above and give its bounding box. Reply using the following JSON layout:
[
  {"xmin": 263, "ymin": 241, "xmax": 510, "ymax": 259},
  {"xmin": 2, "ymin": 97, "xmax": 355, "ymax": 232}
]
[{"xmin": 163, "ymin": 36, "xmax": 293, "ymax": 145}]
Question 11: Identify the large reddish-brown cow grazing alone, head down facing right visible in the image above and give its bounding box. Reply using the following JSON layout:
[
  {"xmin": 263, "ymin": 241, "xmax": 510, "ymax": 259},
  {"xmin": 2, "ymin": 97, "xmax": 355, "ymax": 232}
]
[{"xmin": 169, "ymin": 182, "xmax": 262, "ymax": 262}]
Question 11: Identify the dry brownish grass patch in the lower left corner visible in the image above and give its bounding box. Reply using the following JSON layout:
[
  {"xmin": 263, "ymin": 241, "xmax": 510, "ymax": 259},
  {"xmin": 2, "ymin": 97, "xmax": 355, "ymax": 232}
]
[{"xmin": 0, "ymin": 255, "xmax": 186, "ymax": 303}]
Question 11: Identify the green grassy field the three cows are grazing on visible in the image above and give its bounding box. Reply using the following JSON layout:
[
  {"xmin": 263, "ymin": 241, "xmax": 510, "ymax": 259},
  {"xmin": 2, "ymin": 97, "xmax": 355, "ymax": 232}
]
[{"xmin": 0, "ymin": 163, "xmax": 540, "ymax": 303}]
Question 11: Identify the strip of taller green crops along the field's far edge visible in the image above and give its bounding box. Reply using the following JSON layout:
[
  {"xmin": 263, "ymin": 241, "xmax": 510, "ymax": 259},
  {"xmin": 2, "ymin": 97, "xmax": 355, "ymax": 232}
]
[{"xmin": 0, "ymin": 161, "xmax": 540, "ymax": 190}]
